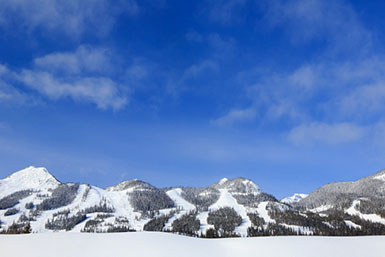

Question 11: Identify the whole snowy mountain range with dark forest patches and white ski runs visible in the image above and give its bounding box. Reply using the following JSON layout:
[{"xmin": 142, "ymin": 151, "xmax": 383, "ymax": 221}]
[{"xmin": 0, "ymin": 167, "xmax": 385, "ymax": 237}]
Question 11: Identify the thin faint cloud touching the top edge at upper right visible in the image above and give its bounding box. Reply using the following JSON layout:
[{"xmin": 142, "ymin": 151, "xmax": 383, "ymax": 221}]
[{"xmin": 264, "ymin": 0, "xmax": 371, "ymax": 51}]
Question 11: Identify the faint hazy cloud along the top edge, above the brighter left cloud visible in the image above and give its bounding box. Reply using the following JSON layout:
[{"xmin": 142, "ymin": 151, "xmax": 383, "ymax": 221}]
[{"xmin": 0, "ymin": 0, "xmax": 139, "ymax": 38}]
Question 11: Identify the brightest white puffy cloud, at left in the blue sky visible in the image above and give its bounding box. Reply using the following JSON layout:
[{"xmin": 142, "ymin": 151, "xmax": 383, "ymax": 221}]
[{"xmin": 0, "ymin": 46, "xmax": 131, "ymax": 110}]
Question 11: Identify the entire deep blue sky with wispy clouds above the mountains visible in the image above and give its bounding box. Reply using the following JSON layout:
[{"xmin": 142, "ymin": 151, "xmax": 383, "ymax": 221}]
[{"xmin": 0, "ymin": 0, "xmax": 385, "ymax": 198}]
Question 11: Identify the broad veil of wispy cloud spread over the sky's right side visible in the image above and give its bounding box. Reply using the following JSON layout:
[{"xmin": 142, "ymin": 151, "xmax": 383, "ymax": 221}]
[{"xmin": 216, "ymin": 0, "xmax": 385, "ymax": 144}]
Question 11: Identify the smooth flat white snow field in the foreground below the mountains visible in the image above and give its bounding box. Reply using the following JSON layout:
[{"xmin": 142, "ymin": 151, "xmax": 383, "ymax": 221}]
[{"xmin": 0, "ymin": 232, "xmax": 385, "ymax": 257}]
